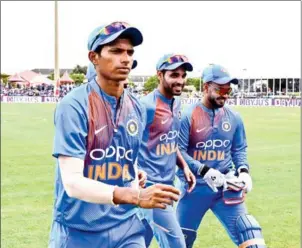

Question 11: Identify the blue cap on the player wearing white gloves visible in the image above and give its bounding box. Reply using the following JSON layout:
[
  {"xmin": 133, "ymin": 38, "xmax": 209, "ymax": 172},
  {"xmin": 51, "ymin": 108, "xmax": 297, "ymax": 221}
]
[{"xmin": 201, "ymin": 64, "xmax": 238, "ymax": 84}]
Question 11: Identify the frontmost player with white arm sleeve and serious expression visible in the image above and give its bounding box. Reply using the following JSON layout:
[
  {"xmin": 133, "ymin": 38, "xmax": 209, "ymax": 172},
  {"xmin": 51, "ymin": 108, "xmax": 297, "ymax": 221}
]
[{"xmin": 49, "ymin": 22, "xmax": 179, "ymax": 248}]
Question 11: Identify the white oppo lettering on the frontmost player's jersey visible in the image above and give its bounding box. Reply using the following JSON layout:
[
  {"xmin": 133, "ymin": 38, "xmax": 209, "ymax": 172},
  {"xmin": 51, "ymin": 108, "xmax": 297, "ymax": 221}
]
[{"xmin": 89, "ymin": 146, "xmax": 133, "ymax": 162}]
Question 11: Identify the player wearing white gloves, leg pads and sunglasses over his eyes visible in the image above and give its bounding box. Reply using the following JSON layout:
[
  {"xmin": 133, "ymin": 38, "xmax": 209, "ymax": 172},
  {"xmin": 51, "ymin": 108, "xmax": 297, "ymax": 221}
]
[{"xmin": 177, "ymin": 64, "xmax": 266, "ymax": 248}]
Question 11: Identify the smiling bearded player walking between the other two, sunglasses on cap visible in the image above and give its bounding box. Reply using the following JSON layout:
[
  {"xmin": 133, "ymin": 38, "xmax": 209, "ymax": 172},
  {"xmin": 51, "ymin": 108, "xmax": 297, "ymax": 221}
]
[{"xmin": 138, "ymin": 54, "xmax": 196, "ymax": 248}]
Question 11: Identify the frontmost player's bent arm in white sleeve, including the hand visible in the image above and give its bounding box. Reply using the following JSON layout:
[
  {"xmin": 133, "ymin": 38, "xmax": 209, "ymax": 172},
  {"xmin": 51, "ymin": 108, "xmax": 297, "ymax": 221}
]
[{"xmin": 59, "ymin": 156, "xmax": 179, "ymax": 208}]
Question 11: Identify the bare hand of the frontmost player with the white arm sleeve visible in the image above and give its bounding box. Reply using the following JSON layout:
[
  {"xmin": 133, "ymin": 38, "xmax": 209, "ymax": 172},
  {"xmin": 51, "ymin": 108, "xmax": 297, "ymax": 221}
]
[{"xmin": 137, "ymin": 184, "xmax": 180, "ymax": 209}]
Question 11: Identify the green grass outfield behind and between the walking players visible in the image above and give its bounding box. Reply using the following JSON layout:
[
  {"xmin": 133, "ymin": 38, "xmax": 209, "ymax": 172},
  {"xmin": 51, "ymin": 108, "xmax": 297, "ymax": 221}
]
[{"xmin": 1, "ymin": 104, "xmax": 301, "ymax": 248}]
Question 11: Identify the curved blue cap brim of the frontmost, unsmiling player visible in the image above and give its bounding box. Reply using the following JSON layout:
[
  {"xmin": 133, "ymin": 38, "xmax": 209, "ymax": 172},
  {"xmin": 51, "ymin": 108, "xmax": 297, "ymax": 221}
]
[{"xmin": 91, "ymin": 27, "xmax": 143, "ymax": 51}]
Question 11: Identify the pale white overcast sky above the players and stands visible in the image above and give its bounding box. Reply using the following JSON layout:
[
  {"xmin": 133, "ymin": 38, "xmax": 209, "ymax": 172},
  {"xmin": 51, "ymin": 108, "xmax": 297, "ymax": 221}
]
[{"xmin": 1, "ymin": 1, "xmax": 301, "ymax": 77}]
